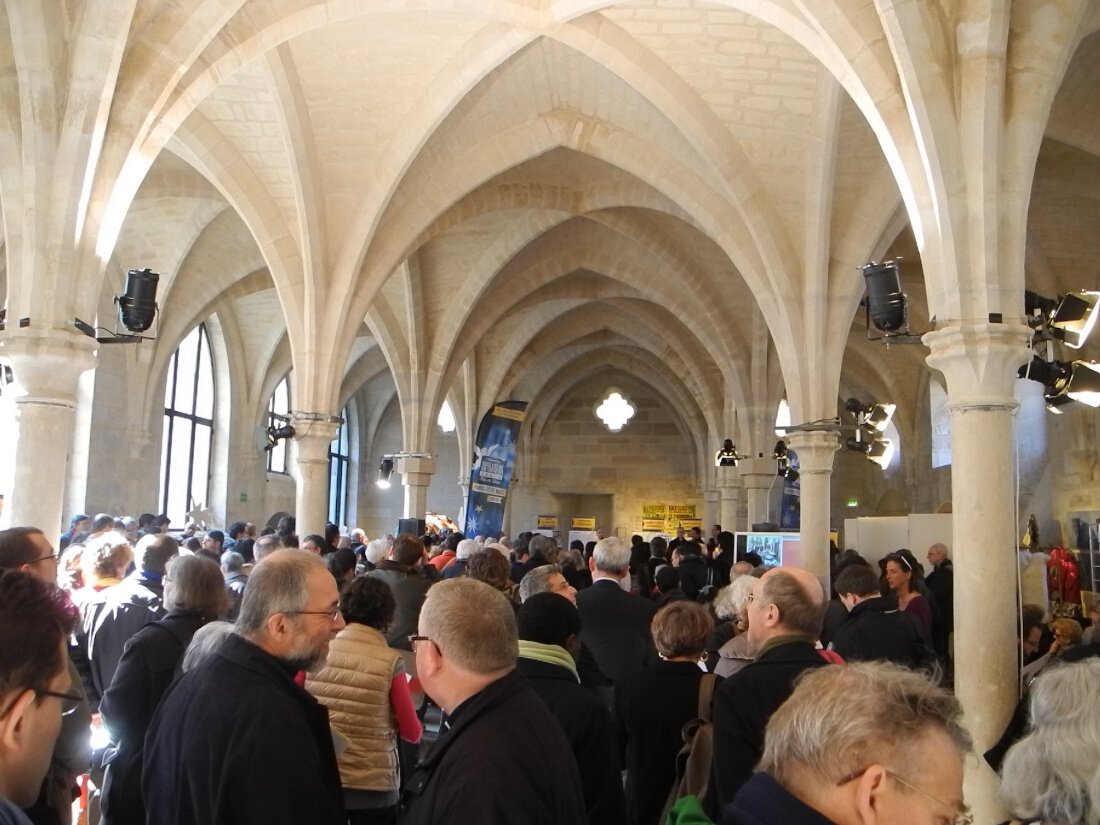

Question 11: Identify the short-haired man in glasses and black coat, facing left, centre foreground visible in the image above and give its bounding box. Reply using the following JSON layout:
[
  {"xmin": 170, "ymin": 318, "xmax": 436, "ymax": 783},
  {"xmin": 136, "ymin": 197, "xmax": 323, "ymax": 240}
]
[{"xmin": 396, "ymin": 576, "xmax": 586, "ymax": 825}]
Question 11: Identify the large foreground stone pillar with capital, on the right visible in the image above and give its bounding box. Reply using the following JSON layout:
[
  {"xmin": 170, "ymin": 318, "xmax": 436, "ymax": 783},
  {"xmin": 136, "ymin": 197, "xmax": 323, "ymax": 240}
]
[{"xmin": 912, "ymin": 323, "xmax": 1031, "ymax": 822}]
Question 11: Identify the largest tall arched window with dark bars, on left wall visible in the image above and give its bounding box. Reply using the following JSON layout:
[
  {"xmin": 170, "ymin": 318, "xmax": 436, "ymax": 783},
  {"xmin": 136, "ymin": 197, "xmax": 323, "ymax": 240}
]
[{"xmin": 161, "ymin": 323, "xmax": 215, "ymax": 524}]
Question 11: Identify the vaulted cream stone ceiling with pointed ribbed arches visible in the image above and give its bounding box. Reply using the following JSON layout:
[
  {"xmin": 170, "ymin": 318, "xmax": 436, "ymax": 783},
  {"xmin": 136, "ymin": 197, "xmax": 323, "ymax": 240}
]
[{"xmin": 23, "ymin": 0, "xmax": 1100, "ymax": 470}]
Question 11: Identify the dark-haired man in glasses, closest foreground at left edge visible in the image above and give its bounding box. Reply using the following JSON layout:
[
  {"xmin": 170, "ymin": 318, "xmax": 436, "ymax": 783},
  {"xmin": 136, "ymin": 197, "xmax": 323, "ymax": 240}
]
[{"xmin": 0, "ymin": 570, "xmax": 83, "ymax": 825}]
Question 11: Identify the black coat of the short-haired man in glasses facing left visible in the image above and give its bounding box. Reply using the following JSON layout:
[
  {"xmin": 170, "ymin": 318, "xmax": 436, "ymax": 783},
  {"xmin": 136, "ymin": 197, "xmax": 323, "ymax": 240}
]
[{"xmin": 400, "ymin": 671, "xmax": 600, "ymax": 825}]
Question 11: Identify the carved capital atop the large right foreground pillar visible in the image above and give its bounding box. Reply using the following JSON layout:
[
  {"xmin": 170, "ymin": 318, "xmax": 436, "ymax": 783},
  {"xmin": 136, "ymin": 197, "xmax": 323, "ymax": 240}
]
[{"xmin": 921, "ymin": 323, "xmax": 1032, "ymax": 410}]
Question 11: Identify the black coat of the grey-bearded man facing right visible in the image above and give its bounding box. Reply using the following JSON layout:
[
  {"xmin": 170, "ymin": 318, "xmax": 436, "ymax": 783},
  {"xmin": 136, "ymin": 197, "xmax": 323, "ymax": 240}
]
[{"xmin": 142, "ymin": 635, "xmax": 348, "ymax": 825}]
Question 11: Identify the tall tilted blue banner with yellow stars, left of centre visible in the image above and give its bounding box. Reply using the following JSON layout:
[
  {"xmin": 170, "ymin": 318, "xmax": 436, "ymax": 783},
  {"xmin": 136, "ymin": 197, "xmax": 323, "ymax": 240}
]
[{"xmin": 465, "ymin": 402, "xmax": 527, "ymax": 537}]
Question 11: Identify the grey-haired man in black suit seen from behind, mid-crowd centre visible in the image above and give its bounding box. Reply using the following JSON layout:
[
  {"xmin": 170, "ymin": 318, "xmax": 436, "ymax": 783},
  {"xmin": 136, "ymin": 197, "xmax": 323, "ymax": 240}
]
[{"xmin": 576, "ymin": 543, "xmax": 657, "ymax": 699}]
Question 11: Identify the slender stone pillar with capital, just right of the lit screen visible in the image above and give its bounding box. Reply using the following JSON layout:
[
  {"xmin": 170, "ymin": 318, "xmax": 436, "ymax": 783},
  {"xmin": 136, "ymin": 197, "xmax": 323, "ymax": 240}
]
[{"xmin": 788, "ymin": 430, "xmax": 840, "ymax": 580}]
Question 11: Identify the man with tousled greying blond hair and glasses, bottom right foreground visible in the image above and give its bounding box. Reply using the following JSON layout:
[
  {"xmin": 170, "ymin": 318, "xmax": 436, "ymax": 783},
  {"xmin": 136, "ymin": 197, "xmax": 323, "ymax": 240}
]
[{"xmin": 722, "ymin": 662, "xmax": 972, "ymax": 825}]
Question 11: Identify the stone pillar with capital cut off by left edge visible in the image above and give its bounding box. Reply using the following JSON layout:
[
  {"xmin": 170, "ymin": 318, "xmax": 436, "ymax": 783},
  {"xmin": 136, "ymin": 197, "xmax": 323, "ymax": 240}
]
[{"xmin": 0, "ymin": 336, "xmax": 96, "ymax": 536}]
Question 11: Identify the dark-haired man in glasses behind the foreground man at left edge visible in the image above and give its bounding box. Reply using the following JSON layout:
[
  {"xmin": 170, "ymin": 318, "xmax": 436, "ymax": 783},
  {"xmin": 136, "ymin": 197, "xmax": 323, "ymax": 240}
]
[{"xmin": 0, "ymin": 527, "xmax": 91, "ymax": 825}]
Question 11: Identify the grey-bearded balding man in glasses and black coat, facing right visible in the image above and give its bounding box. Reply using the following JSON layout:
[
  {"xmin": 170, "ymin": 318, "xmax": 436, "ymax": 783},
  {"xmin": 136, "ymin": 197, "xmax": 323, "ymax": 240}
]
[{"xmin": 142, "ymin": 550, "xmax": 347, "ymax": 825}]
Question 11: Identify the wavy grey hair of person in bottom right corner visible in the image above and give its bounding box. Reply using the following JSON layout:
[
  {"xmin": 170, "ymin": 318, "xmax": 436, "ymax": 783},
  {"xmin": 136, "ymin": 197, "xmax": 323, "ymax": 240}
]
[{"xmin": 1001, "ymin": 658, "xmax": 1100, "ymax": 825}]
